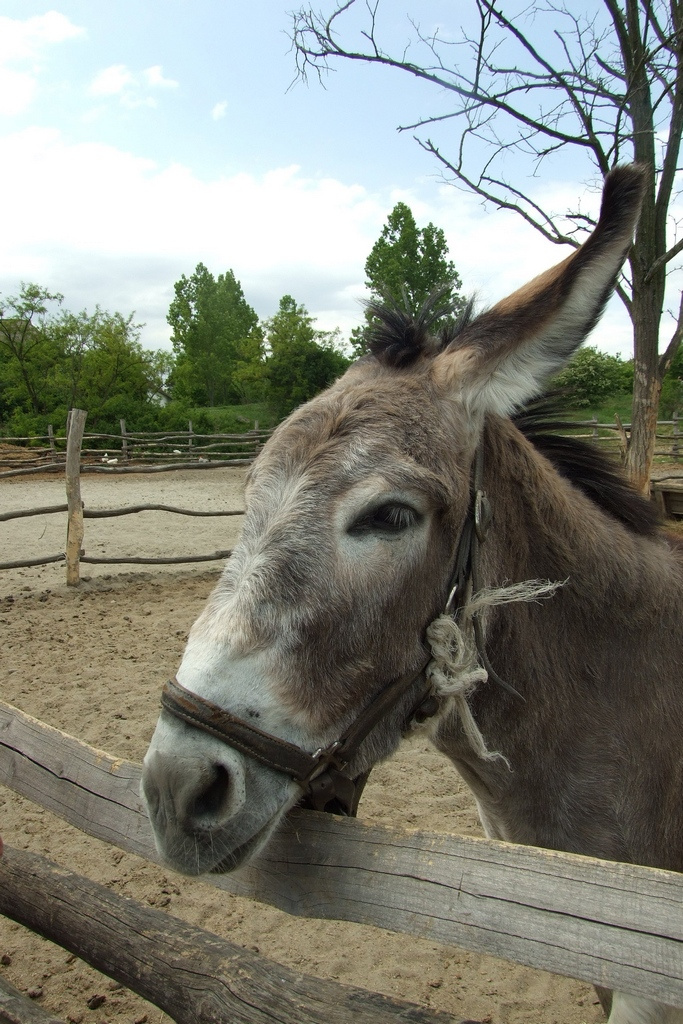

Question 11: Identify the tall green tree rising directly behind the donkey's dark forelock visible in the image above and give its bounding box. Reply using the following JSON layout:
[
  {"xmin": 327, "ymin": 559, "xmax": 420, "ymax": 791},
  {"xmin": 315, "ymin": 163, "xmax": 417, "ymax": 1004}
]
[{"xmin": 351, "ymin": 203, "xmax": 464, "ymax": 355}]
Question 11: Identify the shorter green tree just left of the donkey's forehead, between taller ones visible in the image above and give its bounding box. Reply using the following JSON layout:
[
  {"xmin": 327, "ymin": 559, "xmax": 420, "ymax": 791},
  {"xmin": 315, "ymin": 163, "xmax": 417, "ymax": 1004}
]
[{"xmin": 265, "ymin": 295, "xmax": 351, "ymax": 417}]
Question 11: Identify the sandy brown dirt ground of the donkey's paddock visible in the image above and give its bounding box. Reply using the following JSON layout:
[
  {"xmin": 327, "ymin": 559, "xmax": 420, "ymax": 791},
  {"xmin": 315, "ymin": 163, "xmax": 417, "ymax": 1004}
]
[{"xmin": 0, "ymin": 469, "xmax": 603, "ymax": 1024}]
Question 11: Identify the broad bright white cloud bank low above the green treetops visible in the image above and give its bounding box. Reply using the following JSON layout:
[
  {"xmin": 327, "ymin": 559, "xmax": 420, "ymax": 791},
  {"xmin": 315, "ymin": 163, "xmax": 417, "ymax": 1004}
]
[{"xmin": 0, "ymin": 128, "xmax": 655, "ymax": 356}]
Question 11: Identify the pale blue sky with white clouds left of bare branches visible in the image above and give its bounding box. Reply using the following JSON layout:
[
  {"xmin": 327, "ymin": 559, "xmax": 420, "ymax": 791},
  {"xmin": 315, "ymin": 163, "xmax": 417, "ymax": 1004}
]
[{"xmin": 0, "ymin": 0, "xmax": 671, "ymax": 357}]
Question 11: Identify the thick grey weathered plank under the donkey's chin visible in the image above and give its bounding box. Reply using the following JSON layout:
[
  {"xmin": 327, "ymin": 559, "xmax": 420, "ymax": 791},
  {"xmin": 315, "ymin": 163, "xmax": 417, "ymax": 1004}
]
[{"xmin": 0, "ymin": 703, "xmax": 683, "ymax": 1007}]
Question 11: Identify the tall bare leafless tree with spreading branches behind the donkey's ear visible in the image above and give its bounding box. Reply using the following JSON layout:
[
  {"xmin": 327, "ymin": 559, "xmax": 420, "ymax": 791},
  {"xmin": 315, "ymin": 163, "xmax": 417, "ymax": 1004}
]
[{"xmin": 293, "ymin": 0, "xmax": 683, "ymax": 493}]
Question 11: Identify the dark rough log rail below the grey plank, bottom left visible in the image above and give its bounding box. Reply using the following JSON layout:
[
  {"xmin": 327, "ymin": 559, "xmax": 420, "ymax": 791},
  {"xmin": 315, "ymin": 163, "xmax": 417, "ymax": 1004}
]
[{"xmin": 0, "ymin": 849, "xmax": 453, "ymax": 1024}]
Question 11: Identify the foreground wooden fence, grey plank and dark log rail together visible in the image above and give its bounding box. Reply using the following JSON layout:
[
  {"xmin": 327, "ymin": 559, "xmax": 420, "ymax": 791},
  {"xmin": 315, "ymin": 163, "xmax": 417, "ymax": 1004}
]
[{"xmin": 0, "ymin": 702, "xmax": 683, "ymax": 1024}]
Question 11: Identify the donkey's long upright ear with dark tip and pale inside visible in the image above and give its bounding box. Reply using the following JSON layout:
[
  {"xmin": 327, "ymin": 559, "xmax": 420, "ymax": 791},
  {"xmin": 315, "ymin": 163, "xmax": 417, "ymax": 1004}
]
[{"xmin": 434, "ymin": 164, "xmax": 645, "ymax": 415}]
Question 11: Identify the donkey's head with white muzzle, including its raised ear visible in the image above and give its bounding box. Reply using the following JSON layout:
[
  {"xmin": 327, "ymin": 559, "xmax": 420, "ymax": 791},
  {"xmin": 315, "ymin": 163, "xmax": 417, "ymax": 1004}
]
[{"xmin": 143, "ymin": 167, "xmax": 642, "ymax": 873}]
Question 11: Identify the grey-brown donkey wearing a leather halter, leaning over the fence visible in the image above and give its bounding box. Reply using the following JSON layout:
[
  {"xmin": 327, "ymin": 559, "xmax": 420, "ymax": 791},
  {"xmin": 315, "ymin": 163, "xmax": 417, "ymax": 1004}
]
[{"xmin": 142, "ymin": 166, "xmax": 683, "ymax": 1024}]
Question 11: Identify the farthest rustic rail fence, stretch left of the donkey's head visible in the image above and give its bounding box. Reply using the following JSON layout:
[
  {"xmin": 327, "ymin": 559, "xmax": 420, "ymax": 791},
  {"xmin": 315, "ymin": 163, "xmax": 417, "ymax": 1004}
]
[{"xmin": 0, "ymin": 413, "xmax": 272, "ymax": 477}]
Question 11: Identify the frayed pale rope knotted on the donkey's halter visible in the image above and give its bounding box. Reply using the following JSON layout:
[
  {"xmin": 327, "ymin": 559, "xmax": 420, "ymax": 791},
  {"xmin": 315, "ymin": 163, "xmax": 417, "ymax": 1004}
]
[{"xmin": 426, "ymin": 580, "xmax": 566, "ymax": 767}]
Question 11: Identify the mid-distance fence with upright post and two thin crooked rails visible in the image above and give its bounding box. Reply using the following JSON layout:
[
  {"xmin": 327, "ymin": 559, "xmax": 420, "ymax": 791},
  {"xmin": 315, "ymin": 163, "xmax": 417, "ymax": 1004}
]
[{"xmin": 0, "ymin": 409, "xmax": 244, "ymax": 585}]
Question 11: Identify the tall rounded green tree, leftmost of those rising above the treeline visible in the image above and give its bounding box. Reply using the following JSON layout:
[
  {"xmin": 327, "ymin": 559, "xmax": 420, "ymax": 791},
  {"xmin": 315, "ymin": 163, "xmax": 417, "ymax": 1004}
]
[{"xmin": 167, "ymin": 263, "xmax": 258, "ymax": 407}]
